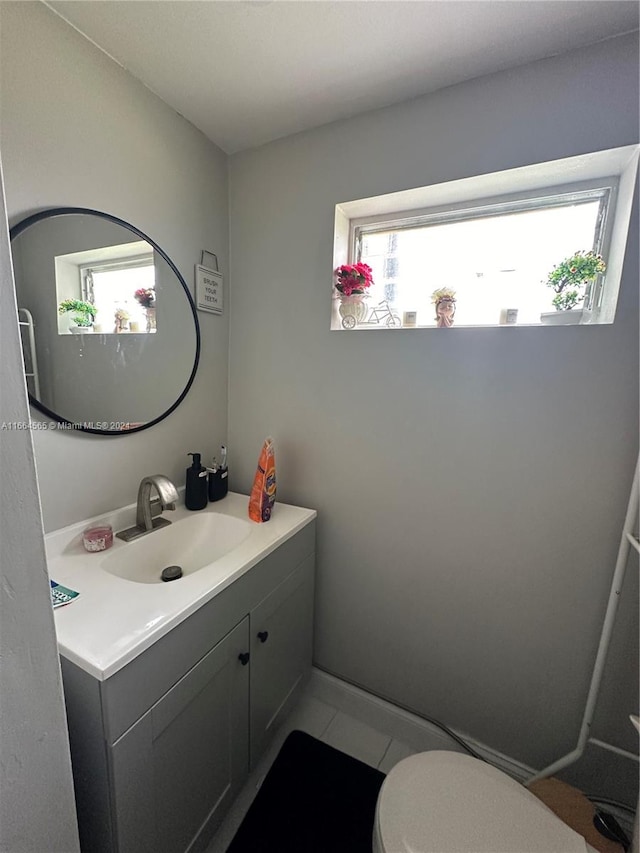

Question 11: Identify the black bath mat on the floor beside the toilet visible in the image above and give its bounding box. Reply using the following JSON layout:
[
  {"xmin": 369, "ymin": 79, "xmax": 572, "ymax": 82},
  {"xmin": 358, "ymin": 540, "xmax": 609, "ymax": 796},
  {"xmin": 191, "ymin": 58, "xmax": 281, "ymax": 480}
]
[{"xmin": 227, "ymin": 731, "xmax": 384, "ymax": 853}]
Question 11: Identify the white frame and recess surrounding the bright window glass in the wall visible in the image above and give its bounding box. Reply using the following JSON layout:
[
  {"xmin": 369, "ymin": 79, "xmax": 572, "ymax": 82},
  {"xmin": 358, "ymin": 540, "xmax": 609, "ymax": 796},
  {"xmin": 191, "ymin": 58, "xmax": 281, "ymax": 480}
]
[{"xmin": 331, "ymin": 145, "xmax": 640, "ymax": 329}]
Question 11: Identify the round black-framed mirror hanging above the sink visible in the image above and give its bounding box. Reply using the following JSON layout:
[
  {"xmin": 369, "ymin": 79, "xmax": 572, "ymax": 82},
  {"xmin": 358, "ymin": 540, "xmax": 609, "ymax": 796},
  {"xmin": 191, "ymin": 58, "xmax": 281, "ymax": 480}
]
[{"xmin": 10, "ymin": 207, "xmax": 200, "ymax": 435}]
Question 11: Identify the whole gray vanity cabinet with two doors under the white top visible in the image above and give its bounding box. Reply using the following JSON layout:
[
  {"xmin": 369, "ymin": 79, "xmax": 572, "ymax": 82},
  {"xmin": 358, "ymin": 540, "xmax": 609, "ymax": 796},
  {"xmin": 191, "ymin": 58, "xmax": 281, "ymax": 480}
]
[{"xmin": 61, "ymin": 522, "xmax": 315, "ymax": 853}]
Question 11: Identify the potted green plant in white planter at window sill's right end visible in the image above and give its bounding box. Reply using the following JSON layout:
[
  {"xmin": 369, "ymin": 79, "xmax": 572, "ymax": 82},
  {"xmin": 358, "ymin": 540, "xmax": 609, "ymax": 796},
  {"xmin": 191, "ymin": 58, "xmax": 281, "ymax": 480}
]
[{"xmin": 540, "ymin": 250, "xmax": 607, "ymax": 325}]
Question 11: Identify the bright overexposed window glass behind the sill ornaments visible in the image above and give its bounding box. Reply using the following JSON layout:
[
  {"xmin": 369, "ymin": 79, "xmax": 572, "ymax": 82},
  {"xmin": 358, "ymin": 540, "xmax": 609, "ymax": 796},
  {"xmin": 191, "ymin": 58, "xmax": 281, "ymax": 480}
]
[{"xmin": 354, "ymin": 187, "xmax": 612, "ymax": 325}]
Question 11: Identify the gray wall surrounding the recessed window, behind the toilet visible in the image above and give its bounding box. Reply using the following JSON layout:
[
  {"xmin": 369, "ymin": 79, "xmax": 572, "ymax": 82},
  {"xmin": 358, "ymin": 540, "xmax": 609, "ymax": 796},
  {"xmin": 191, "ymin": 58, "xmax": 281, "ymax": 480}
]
[{"xmin": 229, "ymin": 35, "xmax": 638, "ymax": 782}]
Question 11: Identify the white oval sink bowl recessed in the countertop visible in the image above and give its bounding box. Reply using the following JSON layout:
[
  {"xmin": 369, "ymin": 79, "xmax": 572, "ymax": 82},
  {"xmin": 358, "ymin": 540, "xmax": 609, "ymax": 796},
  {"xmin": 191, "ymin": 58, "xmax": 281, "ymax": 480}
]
[{"xmin": 100, "ymin": 512, "xmax": 252, "ymax": 584}]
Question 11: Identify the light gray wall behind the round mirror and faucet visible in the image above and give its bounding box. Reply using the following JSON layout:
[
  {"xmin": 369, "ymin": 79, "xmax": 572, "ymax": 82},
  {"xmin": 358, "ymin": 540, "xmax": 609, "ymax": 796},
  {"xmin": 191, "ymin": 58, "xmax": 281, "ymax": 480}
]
[{"xmin": 0, "ymin": 2, "xmax": 228, "ymax": 530}]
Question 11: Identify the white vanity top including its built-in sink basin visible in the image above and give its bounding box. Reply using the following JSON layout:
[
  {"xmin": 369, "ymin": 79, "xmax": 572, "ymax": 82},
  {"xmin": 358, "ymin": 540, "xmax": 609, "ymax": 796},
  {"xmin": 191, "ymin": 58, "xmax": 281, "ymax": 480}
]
[{"xmin": 45, "ymin": 492, "xmax": 316, "ymax": 681}]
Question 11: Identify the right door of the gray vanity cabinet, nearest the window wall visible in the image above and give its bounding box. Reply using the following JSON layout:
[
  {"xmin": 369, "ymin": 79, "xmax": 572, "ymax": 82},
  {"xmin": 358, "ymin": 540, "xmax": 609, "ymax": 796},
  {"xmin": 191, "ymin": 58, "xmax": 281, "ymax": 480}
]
[{"xmin": 250, "ymin": 555, "xmax": 315, "ymax": 767}]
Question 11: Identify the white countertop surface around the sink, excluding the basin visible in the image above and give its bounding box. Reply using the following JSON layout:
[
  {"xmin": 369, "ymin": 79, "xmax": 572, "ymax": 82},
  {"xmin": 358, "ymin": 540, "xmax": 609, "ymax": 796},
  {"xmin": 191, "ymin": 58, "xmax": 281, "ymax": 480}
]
[{"xmin": 45, "ymin": 492, "xmax": 316, "ymax": 681}]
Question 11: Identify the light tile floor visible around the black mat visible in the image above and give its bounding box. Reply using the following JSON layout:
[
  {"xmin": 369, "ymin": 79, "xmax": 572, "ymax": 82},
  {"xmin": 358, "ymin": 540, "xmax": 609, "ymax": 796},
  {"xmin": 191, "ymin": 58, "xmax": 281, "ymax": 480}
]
[{"xmin": 206, "ymin": 685, "xmax": 459, "ymax": 853}]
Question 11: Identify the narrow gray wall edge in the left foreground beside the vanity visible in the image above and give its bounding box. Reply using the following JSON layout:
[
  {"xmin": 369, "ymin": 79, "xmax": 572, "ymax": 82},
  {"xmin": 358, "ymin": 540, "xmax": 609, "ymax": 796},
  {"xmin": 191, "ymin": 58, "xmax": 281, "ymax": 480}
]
[{"xmin": 0, "ymin": 163, "xmax": 79, "ymax": 853}]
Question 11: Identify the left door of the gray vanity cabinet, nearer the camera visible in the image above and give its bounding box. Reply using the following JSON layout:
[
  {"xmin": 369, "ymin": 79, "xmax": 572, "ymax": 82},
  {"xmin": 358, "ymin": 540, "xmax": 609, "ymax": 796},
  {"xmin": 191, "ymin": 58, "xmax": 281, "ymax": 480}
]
[{"xmin": 111, "ymin": 617, "xmax": 249, "ymax": 853}]
